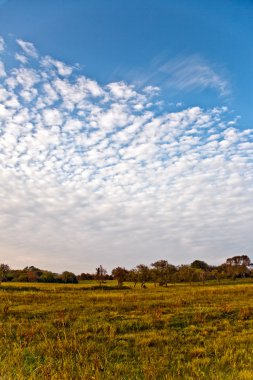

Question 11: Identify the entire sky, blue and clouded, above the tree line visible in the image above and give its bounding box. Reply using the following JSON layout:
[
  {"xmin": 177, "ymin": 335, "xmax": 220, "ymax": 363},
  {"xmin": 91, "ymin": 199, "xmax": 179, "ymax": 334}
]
[{"xmin": 0, "ymin": 0, "xmax": 253, "ymax": 274}]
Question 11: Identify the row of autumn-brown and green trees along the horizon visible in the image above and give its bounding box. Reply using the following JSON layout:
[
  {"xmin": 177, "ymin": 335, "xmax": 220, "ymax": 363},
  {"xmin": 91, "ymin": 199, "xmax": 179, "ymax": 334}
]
[{"xmin": 0, "ymin": 255, "xmax": 253, "ymax": 288}]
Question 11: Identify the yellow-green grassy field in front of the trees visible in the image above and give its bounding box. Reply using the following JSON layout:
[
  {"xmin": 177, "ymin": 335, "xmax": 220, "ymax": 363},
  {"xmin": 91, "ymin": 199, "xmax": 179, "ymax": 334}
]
[{"xmin": 0, "ymin": 282, "xmax": 253, "ymax": 380}]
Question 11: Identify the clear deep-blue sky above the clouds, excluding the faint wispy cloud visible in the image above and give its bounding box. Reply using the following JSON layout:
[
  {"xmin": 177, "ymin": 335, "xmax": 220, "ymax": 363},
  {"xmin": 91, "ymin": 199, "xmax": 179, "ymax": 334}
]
[{"xmin": 0, "ymin": 0, "xmax": 253, "ymax": 123}]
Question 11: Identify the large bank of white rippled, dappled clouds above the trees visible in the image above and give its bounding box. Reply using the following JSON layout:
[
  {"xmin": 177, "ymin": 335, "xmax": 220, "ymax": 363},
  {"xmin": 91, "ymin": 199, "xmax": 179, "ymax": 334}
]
[{"xmin": 0, "ymin": 38, "xmax": 253, "ymax": 272}]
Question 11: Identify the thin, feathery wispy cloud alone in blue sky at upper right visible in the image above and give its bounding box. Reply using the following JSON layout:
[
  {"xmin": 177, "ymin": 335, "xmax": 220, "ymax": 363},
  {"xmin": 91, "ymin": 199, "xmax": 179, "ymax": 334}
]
[{"xmin": 125, "ymin": 54, "xmax": 231, "ymax": 97}]
